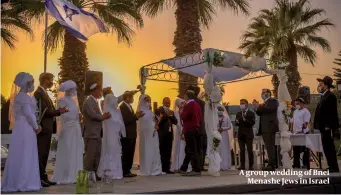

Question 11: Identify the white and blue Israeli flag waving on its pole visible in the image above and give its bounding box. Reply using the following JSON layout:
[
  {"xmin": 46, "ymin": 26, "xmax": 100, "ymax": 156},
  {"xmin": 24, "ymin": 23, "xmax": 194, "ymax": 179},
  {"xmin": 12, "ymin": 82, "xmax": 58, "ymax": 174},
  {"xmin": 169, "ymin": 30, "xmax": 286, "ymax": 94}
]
[{"xmin": 45, "ymin": 0, "xmax": 108, "ymax": 42}]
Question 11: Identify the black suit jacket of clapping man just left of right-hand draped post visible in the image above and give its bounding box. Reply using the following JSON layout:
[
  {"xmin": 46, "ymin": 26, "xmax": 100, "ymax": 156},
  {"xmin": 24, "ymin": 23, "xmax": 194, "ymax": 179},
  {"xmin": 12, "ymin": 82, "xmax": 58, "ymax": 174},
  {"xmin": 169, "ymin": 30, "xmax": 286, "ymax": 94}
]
[{"xmin": 256, "ymin": 98, "xmax": 279, "ymax": 134}]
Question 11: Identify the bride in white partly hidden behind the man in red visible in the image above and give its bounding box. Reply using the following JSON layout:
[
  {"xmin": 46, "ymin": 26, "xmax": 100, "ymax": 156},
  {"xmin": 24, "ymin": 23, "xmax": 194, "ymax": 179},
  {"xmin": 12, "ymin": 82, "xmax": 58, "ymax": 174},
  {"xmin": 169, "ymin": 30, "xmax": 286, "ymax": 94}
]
[{"xmin": 171, "ymin": 98, "xmax": 192, "ymax": 172}]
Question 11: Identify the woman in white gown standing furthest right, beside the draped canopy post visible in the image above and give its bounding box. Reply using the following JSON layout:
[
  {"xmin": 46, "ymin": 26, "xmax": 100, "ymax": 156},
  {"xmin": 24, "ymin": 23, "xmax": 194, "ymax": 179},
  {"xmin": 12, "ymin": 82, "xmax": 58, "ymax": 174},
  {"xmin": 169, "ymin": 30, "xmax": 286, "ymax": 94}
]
[{"xmin": 217, "ymin": 105, "xmax": 232, "ymax": 171}]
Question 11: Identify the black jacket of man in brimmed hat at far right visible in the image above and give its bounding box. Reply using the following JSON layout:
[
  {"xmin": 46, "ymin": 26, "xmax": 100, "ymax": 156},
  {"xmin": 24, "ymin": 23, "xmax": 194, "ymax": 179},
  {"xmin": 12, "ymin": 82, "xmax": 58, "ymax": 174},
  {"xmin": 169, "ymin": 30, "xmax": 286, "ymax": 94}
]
[{"xmin": 314, "ymin": 91, "xmax": 339, "ymax": 131}]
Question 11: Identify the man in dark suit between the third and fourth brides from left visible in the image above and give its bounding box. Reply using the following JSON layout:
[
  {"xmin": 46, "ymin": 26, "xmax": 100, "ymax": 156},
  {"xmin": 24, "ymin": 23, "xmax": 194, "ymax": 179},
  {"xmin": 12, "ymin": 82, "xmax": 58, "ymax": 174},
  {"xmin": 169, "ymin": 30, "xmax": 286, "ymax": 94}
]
[{"xmin": 120, "ymin": 91, "xmax": 144, "ymax": 177}]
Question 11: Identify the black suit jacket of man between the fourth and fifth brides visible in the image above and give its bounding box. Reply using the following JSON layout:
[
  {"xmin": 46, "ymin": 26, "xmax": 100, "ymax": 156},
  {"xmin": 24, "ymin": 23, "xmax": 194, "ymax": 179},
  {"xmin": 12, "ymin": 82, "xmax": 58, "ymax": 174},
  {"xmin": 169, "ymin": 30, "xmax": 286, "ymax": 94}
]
[{"xmin": 155, "ymin": 107, "xmax": 178, "ymax": 136}]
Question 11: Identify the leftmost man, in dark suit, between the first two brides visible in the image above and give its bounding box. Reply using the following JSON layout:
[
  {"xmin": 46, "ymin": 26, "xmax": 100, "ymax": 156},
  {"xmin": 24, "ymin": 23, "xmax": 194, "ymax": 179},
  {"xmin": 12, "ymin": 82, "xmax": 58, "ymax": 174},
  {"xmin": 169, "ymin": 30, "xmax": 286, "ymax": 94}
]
[{"xmin": 34, "ymin": 73, "xmax": 68, "ymax": 187}]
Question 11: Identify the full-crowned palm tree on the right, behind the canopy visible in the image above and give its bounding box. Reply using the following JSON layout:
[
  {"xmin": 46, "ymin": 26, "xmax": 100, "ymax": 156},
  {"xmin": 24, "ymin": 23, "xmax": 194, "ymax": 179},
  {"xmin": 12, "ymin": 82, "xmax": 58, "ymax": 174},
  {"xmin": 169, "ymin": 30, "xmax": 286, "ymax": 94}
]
[{"xmin": 240, "ymin": 0, "xmax": 334, "ymax": 98}]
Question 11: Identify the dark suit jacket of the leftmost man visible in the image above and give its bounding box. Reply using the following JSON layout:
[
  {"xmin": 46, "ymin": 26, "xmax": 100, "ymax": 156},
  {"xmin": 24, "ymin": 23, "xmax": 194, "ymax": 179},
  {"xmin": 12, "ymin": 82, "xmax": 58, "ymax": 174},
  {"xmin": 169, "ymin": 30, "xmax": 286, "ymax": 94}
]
[{"xmin": 34, "ymin": 87, "xmax": 61, "ymax": 133}]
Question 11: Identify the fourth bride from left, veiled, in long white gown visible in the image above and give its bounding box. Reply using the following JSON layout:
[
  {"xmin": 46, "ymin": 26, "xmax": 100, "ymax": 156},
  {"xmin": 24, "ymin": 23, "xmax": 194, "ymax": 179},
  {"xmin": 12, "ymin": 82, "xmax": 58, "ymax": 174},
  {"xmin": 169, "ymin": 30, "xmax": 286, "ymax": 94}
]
[{"xmin": 137, "ymin": 95, "xmax": 164, "ymax": 176}]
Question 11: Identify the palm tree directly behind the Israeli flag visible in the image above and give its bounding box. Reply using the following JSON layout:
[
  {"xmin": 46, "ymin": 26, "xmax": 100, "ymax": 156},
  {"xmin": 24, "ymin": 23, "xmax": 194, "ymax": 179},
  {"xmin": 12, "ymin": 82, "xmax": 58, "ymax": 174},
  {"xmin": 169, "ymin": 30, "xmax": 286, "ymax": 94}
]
[{"xmin": 10, "ymin": 0, "xmax": 143, "ymax": 105}]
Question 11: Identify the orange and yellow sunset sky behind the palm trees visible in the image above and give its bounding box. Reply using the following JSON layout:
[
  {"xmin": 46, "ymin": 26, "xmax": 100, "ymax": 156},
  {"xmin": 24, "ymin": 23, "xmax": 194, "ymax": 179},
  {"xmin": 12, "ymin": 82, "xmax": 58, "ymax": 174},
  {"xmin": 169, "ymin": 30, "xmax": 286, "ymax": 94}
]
[{"xmin": 1, "ymin": 0, "xmax": 341, "ymax": 107}]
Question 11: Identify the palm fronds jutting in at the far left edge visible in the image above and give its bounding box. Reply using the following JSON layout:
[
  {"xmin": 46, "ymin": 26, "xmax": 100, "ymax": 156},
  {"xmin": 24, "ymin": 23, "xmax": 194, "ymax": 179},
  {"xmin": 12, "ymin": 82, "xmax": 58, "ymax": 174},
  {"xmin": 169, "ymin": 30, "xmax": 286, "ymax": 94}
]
[{"xmin": 1, "ymin": 1, "xmax": 33, "ymax": 49}]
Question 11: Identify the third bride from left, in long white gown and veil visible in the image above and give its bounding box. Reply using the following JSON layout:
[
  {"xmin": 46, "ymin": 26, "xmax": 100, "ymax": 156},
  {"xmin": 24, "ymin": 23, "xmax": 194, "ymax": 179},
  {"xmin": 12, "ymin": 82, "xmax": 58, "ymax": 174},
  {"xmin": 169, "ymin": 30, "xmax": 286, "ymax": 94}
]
[{"xmin": 97, "ymin": 94, "xmax": 126, "ymax": 179}]
